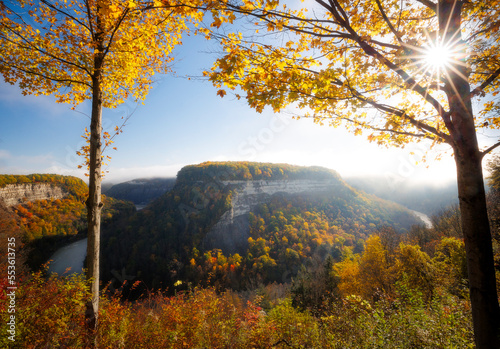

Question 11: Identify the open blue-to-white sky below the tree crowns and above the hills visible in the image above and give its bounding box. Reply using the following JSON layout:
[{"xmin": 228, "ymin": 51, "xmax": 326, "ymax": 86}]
[{"xmin": 0, "ymin": 29, "xmax": 455, "ymax": 184}]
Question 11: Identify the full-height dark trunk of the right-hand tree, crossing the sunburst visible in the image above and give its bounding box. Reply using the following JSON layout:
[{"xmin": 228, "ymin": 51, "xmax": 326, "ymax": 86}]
[{"xmin": 438, "ymin": 0, "xmax": 500, "ymax": 349}]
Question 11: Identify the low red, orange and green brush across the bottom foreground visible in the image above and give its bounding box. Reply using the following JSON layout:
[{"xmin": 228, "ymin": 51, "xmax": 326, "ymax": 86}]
[{"xmin": 0, "ymin": 230, "xmax": 472, "ymax": 349}]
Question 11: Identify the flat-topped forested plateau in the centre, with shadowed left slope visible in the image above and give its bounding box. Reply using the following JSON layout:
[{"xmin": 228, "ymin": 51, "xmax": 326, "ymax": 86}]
[{"xmin": 101, "ymin": 162, "xmax": 421, "ymax": 290}]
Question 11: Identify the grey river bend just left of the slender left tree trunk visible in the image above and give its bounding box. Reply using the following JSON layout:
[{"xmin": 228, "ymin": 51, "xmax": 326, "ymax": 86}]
[{"xmin": 49, "ymin": 238, "xmax": 87, "ymax": 275}]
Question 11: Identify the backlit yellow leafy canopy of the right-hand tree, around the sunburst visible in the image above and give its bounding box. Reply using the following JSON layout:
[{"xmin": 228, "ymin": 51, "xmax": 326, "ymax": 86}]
[{"xmin": 206, "ymin": 0, "xmax": 500, "ymax": 152}]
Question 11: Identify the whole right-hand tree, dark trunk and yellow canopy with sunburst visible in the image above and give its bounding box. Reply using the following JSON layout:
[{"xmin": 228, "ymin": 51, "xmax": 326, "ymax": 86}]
[{"xmin": 207, "ymin": 0, "xmax": 500, "ymax": 342}]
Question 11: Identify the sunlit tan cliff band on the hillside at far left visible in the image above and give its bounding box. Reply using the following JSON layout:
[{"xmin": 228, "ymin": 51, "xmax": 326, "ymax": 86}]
[{"xmin": 0, "ymin": 183, "xmax": 68, "ymax": 207}]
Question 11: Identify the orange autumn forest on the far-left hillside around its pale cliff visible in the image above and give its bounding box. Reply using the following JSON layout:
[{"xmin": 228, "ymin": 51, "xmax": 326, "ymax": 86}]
[{"xmin": 0, "ymin": 174, "xmax": 135, "ymax": 270}]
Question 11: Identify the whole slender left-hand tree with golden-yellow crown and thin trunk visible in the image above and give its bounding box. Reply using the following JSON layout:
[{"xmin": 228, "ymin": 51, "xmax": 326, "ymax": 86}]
[{"xmin": 0, "ymin": 0, "xmax": 203, "ymax": 327}]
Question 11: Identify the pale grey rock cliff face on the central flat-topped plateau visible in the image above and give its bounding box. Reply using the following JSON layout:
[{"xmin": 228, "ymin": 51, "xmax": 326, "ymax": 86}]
[{"xmin": 203, "ymin": 179, "xmax": 339, "ymax": 253}]
